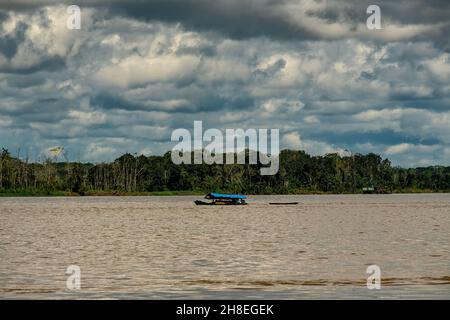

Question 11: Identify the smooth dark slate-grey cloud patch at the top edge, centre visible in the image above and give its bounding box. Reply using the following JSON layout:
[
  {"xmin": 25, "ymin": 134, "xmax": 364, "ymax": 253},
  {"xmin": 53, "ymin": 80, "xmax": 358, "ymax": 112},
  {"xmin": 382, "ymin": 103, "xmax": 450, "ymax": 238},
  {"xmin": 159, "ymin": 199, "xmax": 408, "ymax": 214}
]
[{"xmin": 108, "ymin": 0, "xmax": 314, "ymax": 39}]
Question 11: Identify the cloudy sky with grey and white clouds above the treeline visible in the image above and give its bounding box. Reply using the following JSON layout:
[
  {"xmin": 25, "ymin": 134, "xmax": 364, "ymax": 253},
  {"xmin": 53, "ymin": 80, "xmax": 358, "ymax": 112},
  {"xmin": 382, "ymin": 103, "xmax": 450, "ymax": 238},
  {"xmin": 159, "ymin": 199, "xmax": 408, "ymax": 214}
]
[{"xmin": 0, "ymin": 0, "xmax": 450, "ymax": 167}]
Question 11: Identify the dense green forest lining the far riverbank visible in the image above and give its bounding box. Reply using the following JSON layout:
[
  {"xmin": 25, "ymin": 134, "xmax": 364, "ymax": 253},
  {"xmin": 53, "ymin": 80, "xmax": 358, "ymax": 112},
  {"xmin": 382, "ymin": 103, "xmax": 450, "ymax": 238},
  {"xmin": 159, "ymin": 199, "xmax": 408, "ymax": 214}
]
[{"xmin": 0, "ymin": 149, "xmax": 450, "ymax": 195}]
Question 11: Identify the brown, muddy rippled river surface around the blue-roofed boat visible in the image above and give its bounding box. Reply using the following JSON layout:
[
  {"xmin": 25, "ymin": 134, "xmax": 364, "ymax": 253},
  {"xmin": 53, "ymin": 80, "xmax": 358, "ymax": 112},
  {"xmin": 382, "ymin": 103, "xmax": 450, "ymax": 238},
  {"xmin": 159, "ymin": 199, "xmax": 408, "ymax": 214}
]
[{"xmin": 0, "ymin": 194, "xmax": 450, "ymax": 299}]
